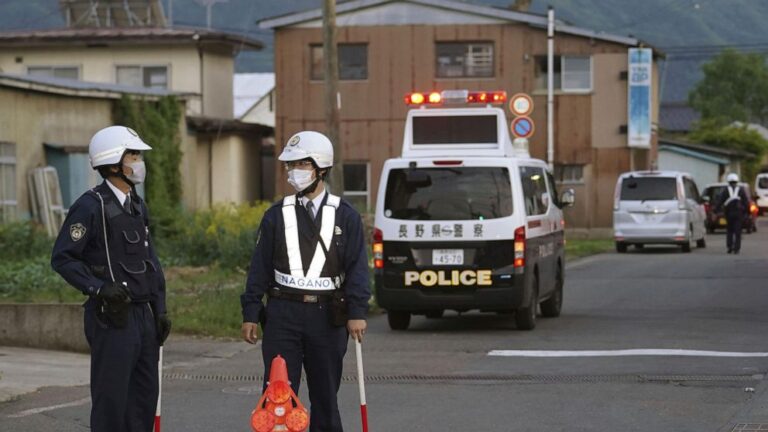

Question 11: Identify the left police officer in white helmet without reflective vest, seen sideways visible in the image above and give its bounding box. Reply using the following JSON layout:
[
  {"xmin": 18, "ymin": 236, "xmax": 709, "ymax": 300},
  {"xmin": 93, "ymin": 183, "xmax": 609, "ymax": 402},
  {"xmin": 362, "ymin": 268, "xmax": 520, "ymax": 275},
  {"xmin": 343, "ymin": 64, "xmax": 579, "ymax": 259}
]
[{"xmin": 51, "ymin": 126, "xmax": 171, "ymax": 432}]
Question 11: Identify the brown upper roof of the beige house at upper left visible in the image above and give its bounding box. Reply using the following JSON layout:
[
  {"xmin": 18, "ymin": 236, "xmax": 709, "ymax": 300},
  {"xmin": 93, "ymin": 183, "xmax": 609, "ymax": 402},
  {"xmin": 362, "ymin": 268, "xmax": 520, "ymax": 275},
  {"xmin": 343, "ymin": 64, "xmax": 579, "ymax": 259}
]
[{"xmin": 0, "ymin": 27, "xmax": 263, "ymax": 50}]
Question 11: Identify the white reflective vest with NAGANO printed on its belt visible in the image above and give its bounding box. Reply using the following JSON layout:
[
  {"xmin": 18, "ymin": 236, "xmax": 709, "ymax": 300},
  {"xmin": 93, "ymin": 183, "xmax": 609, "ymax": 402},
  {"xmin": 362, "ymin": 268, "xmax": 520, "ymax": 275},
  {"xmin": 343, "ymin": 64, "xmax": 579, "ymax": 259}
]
[{"xmin": 275, "ymin": 193, "xmax": 341, "ymax": 291}]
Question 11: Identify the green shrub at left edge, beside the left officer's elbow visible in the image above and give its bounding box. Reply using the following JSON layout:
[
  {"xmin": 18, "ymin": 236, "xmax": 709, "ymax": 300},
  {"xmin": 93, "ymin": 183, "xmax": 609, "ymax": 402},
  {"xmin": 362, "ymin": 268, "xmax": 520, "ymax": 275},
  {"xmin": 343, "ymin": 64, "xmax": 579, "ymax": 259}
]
[{"xmin": 0, "ymin": 222, "xmax": 53, "ymax": 262}]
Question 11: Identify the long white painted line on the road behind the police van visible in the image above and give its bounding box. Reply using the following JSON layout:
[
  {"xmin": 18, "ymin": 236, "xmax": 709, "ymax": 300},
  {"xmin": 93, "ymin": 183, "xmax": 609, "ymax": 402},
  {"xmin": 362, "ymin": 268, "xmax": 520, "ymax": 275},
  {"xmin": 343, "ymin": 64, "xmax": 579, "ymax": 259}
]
[{"xmin": 488, "ymin": 349, "xmax": 768, "ymax": 357}]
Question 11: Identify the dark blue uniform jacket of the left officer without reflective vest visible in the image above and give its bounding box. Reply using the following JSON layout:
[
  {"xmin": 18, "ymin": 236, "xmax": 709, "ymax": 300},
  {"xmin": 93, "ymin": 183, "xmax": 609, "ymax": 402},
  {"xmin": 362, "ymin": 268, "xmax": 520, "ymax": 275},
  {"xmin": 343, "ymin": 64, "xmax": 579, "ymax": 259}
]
[{"xmin": 51, "ymin": 180, "xmax": 166, "ymax": 314}]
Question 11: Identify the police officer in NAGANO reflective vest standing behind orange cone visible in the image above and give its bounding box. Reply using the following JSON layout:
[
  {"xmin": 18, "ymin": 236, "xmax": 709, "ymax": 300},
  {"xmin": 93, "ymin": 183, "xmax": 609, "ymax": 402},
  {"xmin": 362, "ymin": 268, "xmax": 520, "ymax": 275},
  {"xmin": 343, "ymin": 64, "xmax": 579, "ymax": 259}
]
[{"xmin": 241, "ymin": 131, "xmax": 370, "ymax": 432}]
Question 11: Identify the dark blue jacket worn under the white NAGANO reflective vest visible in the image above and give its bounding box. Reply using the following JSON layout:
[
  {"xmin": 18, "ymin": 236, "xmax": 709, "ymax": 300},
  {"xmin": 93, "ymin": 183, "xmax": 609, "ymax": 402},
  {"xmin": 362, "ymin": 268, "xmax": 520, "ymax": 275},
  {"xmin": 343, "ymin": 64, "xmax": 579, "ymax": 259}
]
[{"xmin": 240, "ymin": 192, "xmax": 371, "ymax": 323}]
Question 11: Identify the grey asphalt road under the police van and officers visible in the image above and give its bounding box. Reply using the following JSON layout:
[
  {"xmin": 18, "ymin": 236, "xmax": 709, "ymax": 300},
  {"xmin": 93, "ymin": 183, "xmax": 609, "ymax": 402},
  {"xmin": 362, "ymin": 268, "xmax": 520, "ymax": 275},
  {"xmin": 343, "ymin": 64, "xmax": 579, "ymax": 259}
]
[{"xmin": 0, "ymin": 218, "xmax": 768, "ymax": 432}]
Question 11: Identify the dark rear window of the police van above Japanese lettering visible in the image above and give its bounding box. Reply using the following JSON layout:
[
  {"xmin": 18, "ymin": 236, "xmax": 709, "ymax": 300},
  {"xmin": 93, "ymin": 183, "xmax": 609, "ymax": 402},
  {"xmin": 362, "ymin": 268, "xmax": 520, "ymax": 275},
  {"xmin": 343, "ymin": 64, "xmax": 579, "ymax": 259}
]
[{"xmin": 384, "ymin": 167, "xmax": 512, "ymax": 220}]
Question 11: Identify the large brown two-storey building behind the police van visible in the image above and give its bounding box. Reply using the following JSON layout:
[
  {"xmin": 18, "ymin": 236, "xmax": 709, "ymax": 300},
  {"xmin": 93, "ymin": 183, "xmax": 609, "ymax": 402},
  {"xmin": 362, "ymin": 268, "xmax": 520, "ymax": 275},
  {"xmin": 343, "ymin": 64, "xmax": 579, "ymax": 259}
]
[{"xmin": 261, "ymin": 0, "xmax": 658, "ymax": 232}]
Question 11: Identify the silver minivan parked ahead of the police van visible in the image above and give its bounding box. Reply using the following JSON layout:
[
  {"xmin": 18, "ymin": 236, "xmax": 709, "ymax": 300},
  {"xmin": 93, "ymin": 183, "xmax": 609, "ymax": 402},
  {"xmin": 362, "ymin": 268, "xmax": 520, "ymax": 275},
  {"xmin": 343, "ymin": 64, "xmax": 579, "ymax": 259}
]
[{"xmin": 613, "ymin": 171, "xmax": 706, "ymax": 252}]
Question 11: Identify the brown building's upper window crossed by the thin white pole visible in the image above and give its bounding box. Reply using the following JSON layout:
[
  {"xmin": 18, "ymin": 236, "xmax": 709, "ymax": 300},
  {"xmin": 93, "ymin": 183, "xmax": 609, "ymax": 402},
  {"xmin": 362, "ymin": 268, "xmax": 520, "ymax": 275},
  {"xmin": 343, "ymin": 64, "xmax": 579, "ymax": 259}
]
[{"xmin": 534, "ymin": 56, "xmax": 592, "ymax": 92}]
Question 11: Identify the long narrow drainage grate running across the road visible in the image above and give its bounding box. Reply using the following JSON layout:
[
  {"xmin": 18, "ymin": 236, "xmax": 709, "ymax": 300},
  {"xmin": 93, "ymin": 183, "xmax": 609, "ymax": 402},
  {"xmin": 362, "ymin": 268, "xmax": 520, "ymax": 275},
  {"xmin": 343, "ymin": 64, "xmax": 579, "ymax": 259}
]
[{"xmin": 163, "ymin": 373, "xmax": 768, "ymax": 384}]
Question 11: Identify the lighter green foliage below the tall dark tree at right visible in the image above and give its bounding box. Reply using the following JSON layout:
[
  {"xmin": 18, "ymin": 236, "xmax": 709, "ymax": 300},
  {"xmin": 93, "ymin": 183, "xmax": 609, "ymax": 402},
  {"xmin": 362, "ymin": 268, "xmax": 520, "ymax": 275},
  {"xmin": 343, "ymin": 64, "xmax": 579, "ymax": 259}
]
[{"xmin": 691, "ymin": 119, "xmax": 768, "ymax": 182}]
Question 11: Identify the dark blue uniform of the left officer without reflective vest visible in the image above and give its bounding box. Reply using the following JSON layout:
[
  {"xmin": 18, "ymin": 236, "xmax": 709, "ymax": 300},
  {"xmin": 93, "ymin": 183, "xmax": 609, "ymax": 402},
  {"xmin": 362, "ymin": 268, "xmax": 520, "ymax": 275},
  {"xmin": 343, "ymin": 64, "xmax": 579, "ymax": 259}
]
[{"xmin": 51, "ymin": 181, "xmax": 166, "ymax": 432}]
